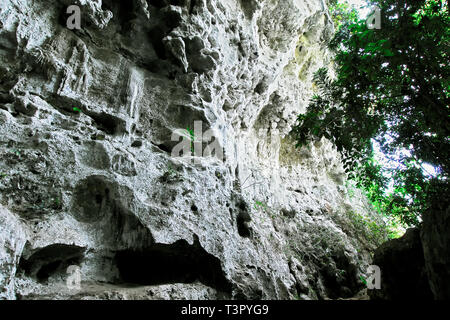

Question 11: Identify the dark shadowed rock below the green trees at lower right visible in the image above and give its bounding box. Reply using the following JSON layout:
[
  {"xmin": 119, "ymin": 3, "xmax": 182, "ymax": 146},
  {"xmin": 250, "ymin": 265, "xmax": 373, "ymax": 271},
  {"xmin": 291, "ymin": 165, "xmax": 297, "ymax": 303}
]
[{"xmin": 368, "ymin": 186, "xmax": 450, "ymax": 300}]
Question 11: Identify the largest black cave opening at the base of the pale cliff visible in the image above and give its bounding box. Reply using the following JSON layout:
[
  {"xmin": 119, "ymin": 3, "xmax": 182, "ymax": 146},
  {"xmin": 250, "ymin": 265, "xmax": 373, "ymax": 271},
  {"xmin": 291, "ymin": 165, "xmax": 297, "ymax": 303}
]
[{"xmin": 115, "ymin": 240, "xmax": 231, "ymax": 293}]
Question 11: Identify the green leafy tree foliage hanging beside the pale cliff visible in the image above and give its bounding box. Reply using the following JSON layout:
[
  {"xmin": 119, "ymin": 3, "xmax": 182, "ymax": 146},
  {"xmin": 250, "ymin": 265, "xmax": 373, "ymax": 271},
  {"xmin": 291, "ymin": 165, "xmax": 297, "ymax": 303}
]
[{"xmin": 293, "ymin": 0, "xmax": 450, "ymax": 229}]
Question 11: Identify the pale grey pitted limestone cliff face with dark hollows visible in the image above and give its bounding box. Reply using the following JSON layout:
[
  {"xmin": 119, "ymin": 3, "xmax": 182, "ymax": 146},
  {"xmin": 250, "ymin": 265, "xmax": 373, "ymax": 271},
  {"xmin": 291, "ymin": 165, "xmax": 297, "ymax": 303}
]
[{"xmin": 0, "ymin": 0, "xmax": 383, "ymax": 299}]
